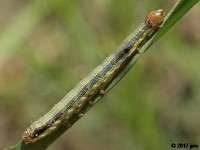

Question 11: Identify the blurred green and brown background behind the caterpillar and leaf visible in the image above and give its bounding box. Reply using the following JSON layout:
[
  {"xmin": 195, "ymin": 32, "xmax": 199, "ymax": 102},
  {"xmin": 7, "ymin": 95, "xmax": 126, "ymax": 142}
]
[{"xmin": 0, "ymin": 0, "xmax": 200, "ymax": 150}]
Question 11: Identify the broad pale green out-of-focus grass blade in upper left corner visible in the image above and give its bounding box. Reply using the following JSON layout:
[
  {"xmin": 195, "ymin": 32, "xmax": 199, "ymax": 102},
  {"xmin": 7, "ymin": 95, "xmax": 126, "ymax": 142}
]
[{"xmin": 0, "ymin": 0, "xmax": 57, "ymax": 65}]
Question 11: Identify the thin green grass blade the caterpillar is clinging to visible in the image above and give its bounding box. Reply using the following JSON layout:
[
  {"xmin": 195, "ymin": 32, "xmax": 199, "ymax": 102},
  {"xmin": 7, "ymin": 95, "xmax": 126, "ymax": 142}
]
[{"xmin": 4, "ymin": 0, "xmax": 199, "ymax": 150}]
